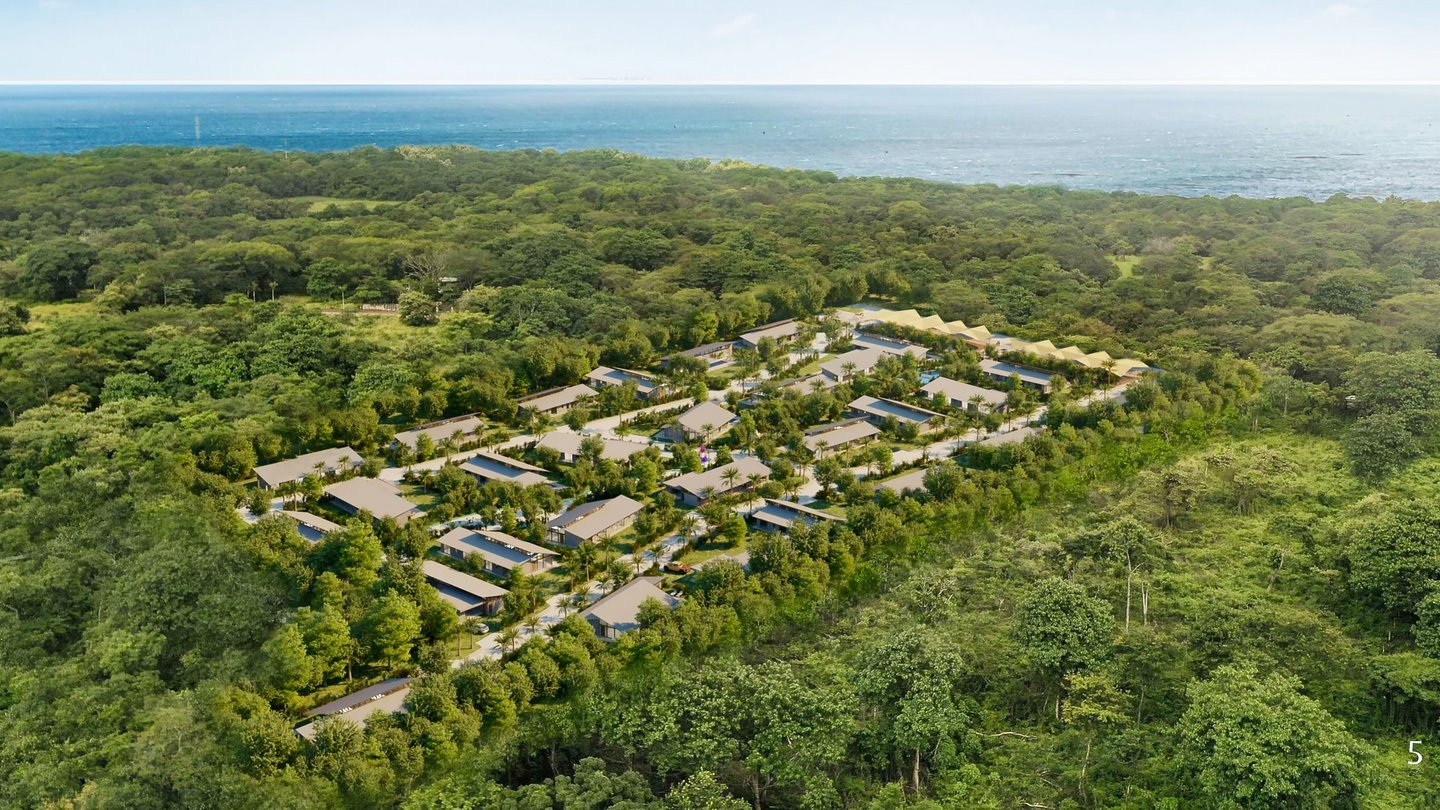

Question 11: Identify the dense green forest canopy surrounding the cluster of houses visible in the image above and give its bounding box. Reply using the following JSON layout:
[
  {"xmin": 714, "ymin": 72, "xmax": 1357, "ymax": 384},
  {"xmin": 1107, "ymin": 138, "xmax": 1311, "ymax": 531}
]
[{"xmin": 0, "ymin": 148, "xmax": 1440, "ymax": 810}]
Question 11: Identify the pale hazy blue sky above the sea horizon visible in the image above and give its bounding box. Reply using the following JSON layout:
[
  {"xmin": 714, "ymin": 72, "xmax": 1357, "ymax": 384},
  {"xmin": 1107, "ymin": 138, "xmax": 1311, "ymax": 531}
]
[{"xmin": 0, "ymin": 0, "xmax": 1440, "ymax": 84}]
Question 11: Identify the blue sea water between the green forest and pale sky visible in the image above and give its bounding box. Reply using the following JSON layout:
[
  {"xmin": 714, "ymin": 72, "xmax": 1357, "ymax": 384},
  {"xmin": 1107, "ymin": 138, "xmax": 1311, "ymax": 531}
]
[{"xmin": 0, "ymin": 86, "xmax": 1440, "ymax": 199}]
